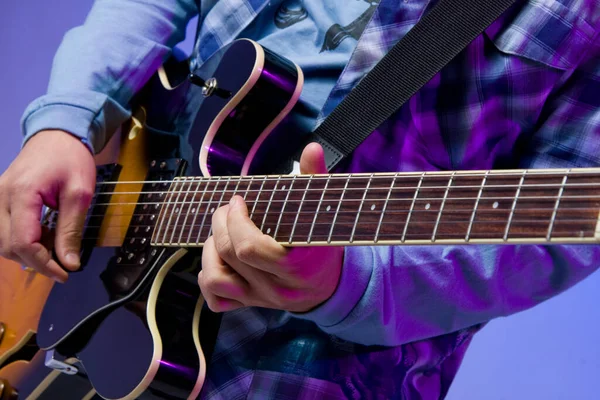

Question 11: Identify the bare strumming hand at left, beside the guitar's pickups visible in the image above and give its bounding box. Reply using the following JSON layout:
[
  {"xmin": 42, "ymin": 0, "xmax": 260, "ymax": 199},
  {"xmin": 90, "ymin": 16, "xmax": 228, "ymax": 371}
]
[{"xmin": 0, "ymin": 130, "xmax": 96, "ymax": 282}]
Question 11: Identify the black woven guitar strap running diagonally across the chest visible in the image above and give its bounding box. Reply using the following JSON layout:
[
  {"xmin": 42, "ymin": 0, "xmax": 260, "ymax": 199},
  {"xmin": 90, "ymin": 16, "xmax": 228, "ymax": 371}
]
[{"xmin": 310, "ymin": 0, "xmax": 516, "ymax": 170}]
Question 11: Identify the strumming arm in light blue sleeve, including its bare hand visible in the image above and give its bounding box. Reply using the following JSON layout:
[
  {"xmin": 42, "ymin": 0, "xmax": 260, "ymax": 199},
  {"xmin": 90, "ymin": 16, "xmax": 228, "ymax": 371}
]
[{"xmin": 0, "ymin": 0, "xmax": 197, "ymax": 282}]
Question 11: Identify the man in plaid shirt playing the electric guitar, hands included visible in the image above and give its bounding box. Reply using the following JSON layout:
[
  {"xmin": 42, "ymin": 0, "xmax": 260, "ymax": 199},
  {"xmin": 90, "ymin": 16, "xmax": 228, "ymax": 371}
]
[{"xmin": 0, "ymin": 0, "xmax": 600, "ymax": 399}]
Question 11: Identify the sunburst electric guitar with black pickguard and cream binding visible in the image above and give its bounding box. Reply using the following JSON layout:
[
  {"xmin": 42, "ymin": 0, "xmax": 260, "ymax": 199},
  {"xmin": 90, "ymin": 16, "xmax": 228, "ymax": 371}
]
[{"xmin": 37, "ymin": 40, "xmax": 600, "ymax": 399}]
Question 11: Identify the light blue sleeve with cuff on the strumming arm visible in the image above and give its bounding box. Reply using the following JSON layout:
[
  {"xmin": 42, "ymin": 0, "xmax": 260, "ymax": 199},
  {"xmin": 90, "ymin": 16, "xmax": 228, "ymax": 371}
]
[{"xmin": 21, "ymin": 0, "xmax": 198, "ymax": 153}]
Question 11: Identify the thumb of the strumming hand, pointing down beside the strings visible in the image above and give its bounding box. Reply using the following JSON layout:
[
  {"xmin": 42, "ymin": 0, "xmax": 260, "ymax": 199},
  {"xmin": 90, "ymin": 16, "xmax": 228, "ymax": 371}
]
[{"xmin": 56, "ymin": 185, "xmax": 93, "ymax": 271}]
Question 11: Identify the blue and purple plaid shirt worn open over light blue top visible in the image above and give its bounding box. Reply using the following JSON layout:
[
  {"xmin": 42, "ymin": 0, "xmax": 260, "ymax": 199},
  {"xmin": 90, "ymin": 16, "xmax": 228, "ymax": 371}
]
[{"xmin": 188, "ymin": 0, "xmax": 600, "ymax": 399}]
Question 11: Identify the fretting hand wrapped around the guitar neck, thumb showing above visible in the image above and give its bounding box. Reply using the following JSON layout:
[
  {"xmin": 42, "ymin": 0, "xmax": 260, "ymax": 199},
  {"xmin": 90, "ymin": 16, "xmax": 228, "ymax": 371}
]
[{"xmin": 198, "ymin": 144, "xmax": 343, "ymax": 312}]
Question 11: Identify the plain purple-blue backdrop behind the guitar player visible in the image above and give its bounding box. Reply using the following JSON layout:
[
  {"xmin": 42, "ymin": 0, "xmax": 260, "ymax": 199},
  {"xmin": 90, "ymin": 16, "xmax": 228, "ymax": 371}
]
[{"xmin": 0, "ymin": 0, "xmax": 600, "ymax": 400}]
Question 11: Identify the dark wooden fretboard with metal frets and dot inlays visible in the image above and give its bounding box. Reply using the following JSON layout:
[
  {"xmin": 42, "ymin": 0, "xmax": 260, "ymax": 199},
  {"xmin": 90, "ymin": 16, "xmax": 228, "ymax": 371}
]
[{"xmin": 152, "ymin": 169, "xmax": 600, "ymax": 247}]
